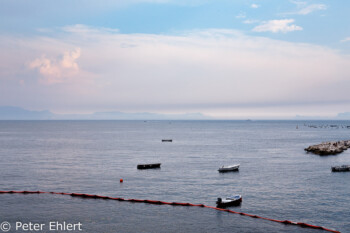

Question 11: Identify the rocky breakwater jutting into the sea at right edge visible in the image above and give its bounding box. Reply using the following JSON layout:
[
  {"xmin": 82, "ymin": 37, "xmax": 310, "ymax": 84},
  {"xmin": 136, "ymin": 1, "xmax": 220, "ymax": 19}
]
[{"xmin": 305, "ymin": 140, "xmax": 350, "ymax": 155}]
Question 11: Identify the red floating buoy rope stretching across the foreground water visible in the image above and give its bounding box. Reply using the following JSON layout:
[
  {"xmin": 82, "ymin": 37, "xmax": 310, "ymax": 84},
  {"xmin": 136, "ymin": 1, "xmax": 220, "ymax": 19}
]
[{"xmin": 0, "ymin": 191, "xmax": 340, "ymax": 233}]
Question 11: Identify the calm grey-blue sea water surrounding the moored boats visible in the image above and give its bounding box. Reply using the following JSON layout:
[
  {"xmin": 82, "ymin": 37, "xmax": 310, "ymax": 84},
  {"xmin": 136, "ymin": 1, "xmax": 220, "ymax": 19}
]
[{"xmin": 0, "ymin": 121, "xmax": 350, "ymax": 232}]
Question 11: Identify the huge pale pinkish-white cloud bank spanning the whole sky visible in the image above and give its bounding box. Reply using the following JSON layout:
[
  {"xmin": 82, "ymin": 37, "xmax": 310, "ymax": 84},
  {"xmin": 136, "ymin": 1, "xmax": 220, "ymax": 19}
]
[{"xmin": 0, "ymin": 25, "xmax": 350, "ymax": 115}]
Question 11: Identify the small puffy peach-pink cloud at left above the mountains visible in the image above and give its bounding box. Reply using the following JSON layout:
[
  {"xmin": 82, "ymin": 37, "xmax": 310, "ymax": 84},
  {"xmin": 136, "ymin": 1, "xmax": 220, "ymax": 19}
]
[{"xmin": 29, "ymin": 48, "xmax": 80, "ymax": 84}]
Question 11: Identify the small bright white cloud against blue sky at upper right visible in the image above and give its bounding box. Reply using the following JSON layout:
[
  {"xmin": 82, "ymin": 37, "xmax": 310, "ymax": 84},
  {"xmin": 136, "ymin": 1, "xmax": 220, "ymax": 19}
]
[{"xmin": 253, "ymin": 19, "xmax": 303, "ymax": 33}]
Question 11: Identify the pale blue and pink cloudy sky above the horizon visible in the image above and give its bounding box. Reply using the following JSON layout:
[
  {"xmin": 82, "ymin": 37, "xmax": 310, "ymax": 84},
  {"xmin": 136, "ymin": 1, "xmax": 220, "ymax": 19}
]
[{"xmin": 0, "ymin": 0, "xmax": 350, "ymax": 119}]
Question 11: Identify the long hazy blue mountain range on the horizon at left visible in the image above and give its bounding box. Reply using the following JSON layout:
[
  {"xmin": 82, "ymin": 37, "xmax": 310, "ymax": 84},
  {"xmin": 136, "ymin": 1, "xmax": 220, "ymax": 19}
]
[{"xmin": 0, "ymin": 106, "xmax": 212, "ymax": 120}]
